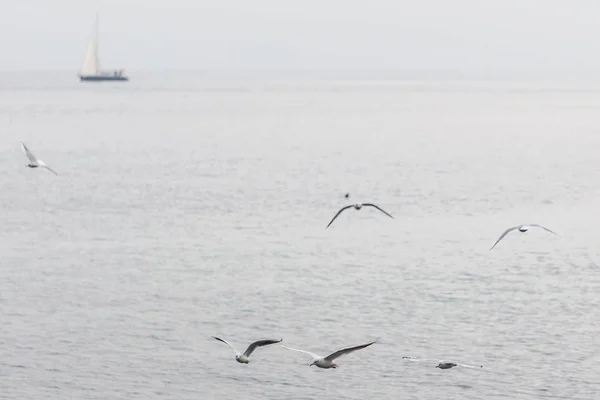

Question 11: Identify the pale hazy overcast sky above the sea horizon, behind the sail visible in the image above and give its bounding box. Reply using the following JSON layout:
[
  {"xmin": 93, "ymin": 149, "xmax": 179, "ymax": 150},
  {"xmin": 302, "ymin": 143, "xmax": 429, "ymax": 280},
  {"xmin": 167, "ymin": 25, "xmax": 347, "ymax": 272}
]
[{"xmin": 0, "ymin": 0, "xmax": 600, "ymax": 70}]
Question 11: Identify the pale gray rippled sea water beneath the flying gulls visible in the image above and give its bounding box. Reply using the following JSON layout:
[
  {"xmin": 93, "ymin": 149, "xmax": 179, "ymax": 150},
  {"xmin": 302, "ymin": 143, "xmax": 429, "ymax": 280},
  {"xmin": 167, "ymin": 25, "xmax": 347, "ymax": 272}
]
[{"xmin": 0, "ymin": 74, "xmax": 600, "ymax": 400}]
